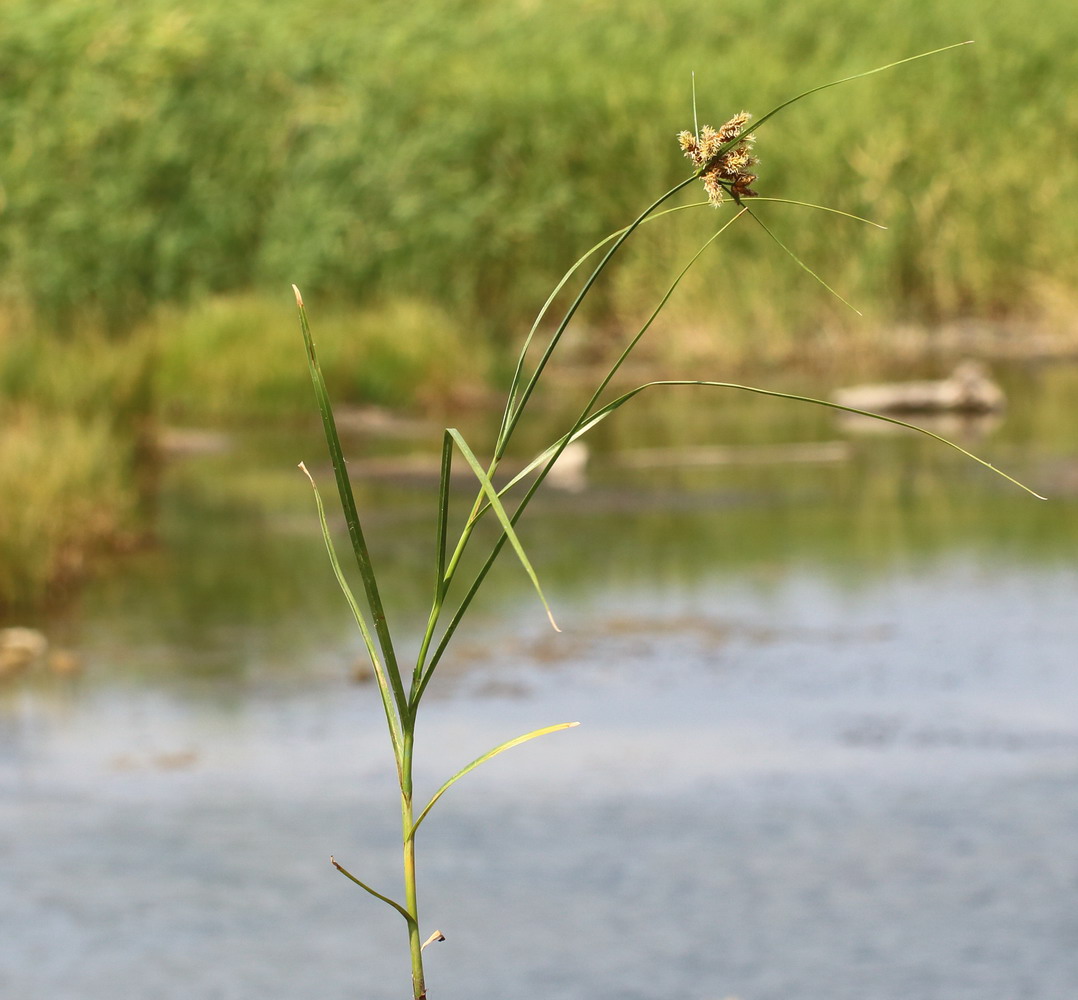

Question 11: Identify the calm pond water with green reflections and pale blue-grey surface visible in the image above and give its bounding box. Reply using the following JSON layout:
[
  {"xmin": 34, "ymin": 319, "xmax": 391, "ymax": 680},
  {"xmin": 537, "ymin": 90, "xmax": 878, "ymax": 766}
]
[{"xmin": 0, "ymin": 367, "xmax": 1078, "ymax": 1000}]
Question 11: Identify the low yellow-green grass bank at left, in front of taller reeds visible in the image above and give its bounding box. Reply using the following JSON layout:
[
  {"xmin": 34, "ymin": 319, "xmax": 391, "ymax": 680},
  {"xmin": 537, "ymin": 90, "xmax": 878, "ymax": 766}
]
[{"xmin": 0, "ymin": 295, "xmax": 485, "ymax": 609}]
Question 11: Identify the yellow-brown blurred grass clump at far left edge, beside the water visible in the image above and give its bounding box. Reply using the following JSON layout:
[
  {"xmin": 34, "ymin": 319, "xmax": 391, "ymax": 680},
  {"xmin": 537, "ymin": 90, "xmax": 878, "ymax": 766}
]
[{"xmin": 0, "ymin": 331, "xmax": 153, "ymax": 609}]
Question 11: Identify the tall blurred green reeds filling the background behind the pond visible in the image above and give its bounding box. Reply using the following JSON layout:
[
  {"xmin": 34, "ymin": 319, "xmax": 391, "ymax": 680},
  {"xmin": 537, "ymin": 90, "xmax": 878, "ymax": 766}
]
[{"xmin": 0, "ymin": 0, "xmax": 1078, "ymax": 346}]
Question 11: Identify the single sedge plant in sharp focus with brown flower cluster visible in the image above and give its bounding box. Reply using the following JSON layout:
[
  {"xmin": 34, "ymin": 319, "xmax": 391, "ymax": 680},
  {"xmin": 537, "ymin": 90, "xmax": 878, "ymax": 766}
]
[{"xmin": 293, "ymin": 42, "xmax": 1044, "ymax": 1000}]
